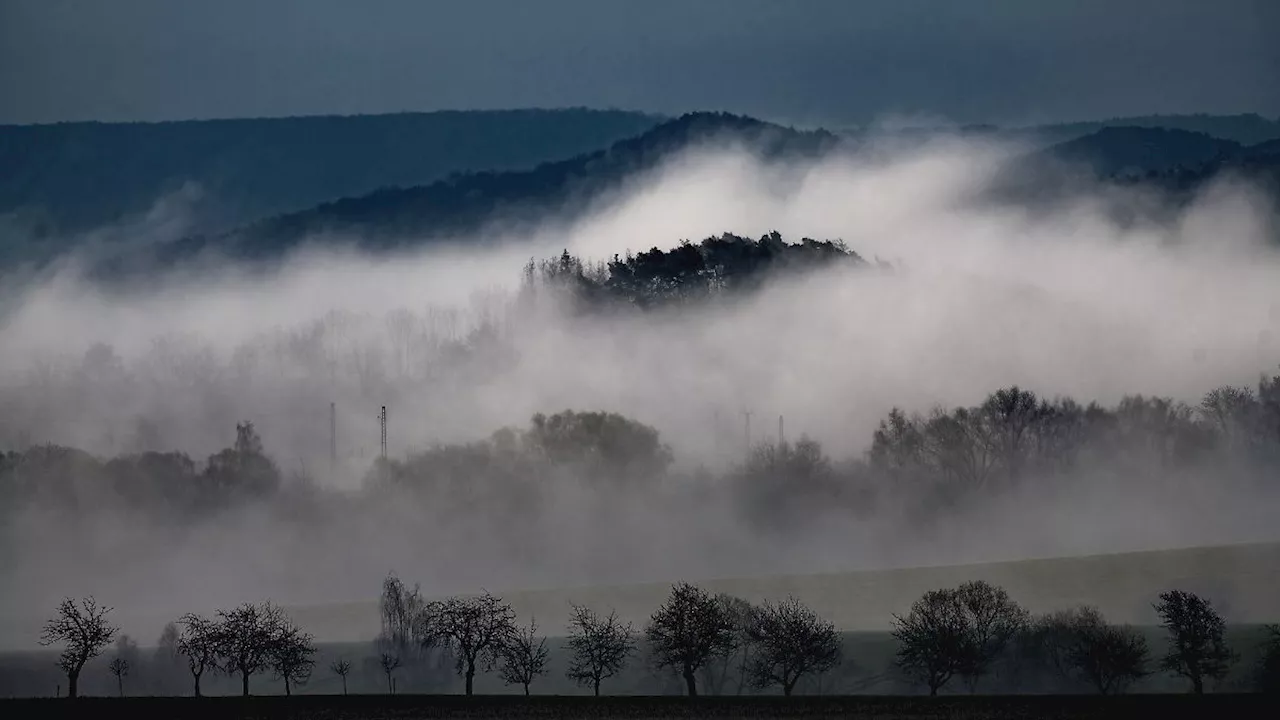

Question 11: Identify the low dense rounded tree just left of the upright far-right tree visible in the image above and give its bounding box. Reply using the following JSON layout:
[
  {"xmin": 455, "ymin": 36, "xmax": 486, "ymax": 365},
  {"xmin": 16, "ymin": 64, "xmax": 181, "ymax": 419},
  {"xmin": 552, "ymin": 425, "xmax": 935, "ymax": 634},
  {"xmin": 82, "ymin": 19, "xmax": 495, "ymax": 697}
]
[{"xmin": 1034, "ymin": 606, "xmax": 1147, "ymax": 694}]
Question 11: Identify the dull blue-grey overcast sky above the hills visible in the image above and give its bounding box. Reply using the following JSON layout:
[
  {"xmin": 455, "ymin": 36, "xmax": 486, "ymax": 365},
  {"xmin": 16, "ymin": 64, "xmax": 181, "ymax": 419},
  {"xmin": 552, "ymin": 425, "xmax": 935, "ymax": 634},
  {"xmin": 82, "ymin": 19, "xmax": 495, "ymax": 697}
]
[{"xmin": 0, "ymin": 0, "xmax": 1280, "ymax": 124}]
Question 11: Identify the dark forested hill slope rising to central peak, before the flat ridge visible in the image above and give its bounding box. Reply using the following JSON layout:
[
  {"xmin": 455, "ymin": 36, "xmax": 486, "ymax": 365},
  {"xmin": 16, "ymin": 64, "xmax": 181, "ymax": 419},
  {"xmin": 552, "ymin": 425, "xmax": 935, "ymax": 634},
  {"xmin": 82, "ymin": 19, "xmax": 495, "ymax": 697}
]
[{"xmin": 99, "ymin": 113, "xmax": 838, "ymax": 272}]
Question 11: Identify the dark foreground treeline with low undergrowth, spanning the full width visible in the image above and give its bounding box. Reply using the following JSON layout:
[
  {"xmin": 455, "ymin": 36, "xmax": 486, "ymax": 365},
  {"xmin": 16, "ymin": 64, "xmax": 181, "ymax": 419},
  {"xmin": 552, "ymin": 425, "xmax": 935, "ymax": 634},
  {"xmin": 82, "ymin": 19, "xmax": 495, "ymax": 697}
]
[{"xmin": 24, "ymin": 573, "xmax": 1280, "ymax": 697}]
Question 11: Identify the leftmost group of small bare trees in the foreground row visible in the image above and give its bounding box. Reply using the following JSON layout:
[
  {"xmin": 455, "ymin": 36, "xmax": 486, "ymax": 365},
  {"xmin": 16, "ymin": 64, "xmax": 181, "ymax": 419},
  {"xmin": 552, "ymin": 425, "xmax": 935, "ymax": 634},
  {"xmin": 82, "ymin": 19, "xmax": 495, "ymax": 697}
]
[{"xmin": 41, "ymin": 597, "xmax": 316, "ymax": 697}]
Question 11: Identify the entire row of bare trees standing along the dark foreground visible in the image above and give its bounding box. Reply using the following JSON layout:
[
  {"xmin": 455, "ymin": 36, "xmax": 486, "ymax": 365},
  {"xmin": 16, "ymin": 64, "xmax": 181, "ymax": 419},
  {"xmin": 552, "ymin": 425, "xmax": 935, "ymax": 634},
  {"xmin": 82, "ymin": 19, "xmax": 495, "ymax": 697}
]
[{"xmin": 42, "ymin": 584, "xmax": 1280, "ymax": 697}]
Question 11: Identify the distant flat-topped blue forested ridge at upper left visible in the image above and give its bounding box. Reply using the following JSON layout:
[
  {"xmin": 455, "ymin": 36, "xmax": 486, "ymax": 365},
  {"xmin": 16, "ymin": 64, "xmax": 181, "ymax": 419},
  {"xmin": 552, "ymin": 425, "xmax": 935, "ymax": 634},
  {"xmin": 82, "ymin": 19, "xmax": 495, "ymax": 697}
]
[{"xmin": 0, "ymin": 109, "xmax": 662, "ymax": 234}]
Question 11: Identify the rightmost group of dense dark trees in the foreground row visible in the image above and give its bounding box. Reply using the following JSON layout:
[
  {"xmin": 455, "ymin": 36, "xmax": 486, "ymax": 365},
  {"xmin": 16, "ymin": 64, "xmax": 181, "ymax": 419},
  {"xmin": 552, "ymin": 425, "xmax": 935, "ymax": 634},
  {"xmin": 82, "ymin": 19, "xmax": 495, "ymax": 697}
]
[{"xmin": 893, "ymin": 580, "xmax": 1244, "ymax": 694}]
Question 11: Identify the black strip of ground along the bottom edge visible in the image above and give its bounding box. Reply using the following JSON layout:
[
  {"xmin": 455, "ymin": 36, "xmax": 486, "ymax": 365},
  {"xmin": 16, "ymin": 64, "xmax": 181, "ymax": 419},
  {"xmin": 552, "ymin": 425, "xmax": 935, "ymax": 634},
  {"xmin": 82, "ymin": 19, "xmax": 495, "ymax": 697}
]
[{"xmin": 0, "ymin": 694, "xmax": 1275, "ymax": 720}]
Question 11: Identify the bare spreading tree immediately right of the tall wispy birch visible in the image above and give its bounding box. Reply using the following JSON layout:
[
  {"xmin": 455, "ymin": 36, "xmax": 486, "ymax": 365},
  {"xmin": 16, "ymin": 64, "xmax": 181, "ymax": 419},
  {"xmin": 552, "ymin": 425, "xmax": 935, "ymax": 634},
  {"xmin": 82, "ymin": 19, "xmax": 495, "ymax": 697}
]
[{"xmin": 416, "ymin": 592, "xmax": 516, "ymax": 694}]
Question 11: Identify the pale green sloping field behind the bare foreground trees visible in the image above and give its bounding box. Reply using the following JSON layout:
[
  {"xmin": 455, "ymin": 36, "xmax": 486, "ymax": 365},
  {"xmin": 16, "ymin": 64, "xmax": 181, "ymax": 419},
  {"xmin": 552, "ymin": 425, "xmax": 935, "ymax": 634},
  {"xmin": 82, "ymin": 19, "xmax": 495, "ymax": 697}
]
[{"xmin": 289, "ymin": 543, "xmax": 1280, "ymax": 642}]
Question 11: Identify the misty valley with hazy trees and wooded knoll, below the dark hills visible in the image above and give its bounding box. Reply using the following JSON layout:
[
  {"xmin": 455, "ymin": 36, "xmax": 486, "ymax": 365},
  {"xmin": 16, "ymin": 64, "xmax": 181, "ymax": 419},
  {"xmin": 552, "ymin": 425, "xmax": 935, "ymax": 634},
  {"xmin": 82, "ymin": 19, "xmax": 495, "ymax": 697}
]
[{"xmin": 0, "ymin": 107, "xmax": 1280, "ymax": 641}]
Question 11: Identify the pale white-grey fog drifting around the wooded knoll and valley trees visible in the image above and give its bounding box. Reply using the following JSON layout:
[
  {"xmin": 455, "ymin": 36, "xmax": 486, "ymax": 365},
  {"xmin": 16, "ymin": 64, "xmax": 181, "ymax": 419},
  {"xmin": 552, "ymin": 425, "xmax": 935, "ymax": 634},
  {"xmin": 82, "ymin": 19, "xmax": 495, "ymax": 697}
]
[{"xmin": 0, "ymin": 137, "xmax": 1280, "ymax": 639}]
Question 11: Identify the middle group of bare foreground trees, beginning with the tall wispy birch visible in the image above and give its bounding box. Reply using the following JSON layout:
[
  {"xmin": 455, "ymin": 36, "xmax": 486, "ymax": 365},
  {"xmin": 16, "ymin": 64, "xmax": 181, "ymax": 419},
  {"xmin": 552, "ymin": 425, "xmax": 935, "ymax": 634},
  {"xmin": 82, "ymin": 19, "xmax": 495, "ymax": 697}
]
[{"xmin": 381, "ymin": 575, "xmax": 841, "ymax": 696}]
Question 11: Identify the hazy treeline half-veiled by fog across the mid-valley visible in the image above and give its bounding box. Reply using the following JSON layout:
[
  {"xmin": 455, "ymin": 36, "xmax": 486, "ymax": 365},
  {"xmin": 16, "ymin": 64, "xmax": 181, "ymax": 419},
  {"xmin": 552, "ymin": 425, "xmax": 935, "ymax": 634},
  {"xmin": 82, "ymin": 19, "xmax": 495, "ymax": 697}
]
[{"xmin": 10, "ymin": 375, "xmax": 1280, "ymax": 535}]
